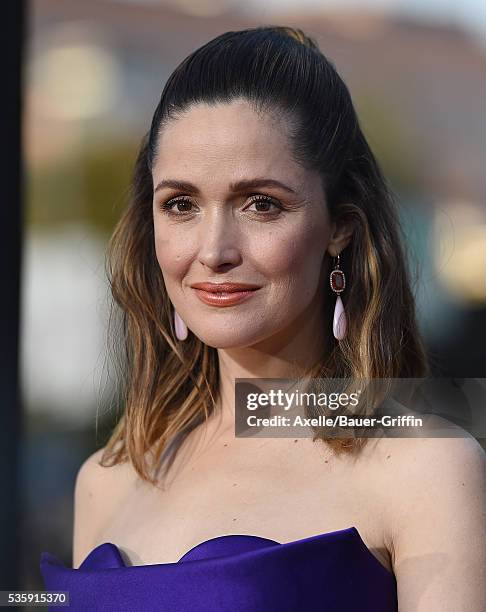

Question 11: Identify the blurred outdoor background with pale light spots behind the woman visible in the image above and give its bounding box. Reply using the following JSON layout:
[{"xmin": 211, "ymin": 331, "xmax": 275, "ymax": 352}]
[{"xmin": 6, "ymin": 0, "xmax": 486, "ymax": 604}]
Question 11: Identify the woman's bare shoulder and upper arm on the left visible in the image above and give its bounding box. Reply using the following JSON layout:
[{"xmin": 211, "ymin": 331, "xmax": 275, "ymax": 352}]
[{"xmin": 73, "ymin": 448, "xmax": 133, "ymax": 567}]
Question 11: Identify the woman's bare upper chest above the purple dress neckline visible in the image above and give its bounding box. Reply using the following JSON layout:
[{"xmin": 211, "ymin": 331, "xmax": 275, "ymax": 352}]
[{"xmin": 97, "ymin": 440, "xmax": 391, "ymax": 569}]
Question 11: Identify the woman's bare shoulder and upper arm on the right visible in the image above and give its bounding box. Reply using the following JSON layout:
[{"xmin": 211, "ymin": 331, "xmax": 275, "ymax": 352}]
[{"xmin": 376, "ymin": 427, "xmax": 486, "ymax": 612}]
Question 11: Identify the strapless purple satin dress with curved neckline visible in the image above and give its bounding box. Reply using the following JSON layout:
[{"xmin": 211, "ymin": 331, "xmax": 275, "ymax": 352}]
[{"xmin": 40, "ymin": 527, "xmax": 398, "ymax": 612}]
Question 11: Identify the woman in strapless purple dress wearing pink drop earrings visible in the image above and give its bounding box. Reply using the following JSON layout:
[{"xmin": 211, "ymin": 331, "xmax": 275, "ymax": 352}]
[{"xmin": 41, "ymin": 27, "xmax": 486, "ymax": 612}]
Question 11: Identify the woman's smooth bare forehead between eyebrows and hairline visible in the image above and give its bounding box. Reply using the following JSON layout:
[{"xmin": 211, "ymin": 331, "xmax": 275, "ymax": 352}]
[{"xmin": 153, "ymin": 103, "xmax": 309, "ymax": 188}]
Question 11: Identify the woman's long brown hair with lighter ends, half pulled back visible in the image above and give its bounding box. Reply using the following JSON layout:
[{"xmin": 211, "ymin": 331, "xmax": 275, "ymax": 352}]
[{"xmin": 98, "ymin": 26, "xmax": 428, "ymax": 483}]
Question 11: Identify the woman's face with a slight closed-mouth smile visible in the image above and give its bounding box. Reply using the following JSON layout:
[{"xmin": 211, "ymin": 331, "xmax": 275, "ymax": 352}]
[{"xmin": 153, "ymin": 100, "xmax": 331, "ymax": 348}]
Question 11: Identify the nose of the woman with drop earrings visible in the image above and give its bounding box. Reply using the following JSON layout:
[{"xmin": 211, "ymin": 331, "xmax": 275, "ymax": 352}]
[{"xmin": 199, "ymin": 211, "xmax": 241, "ymax": 269}]
